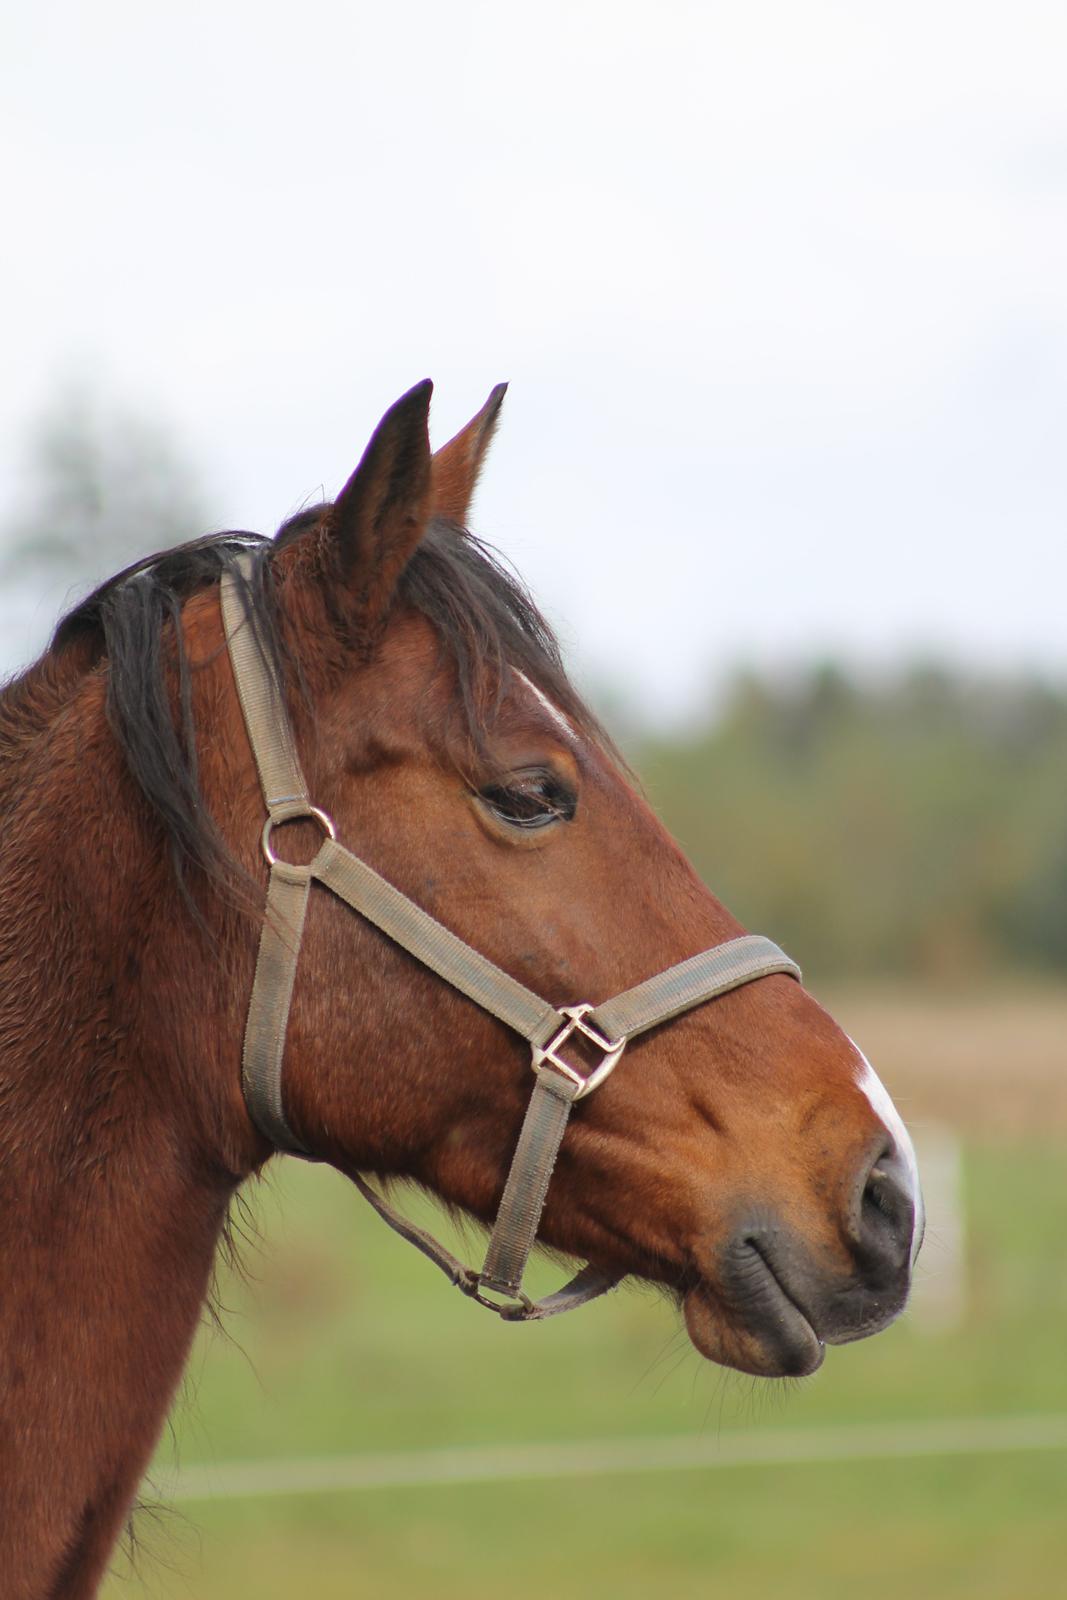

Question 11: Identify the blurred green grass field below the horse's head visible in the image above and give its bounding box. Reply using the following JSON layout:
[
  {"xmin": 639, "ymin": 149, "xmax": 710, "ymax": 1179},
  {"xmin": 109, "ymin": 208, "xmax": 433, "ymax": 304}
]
[{"xmin": 106, "ymin": 1003, "xmax": 1067, "ymax": 1600}]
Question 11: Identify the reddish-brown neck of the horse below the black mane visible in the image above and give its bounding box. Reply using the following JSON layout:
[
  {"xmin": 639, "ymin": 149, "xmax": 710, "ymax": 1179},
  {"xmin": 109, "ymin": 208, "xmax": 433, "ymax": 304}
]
[{"xmin": 0, "ymin": 656, "xmax": 246, "ymax": 1600}]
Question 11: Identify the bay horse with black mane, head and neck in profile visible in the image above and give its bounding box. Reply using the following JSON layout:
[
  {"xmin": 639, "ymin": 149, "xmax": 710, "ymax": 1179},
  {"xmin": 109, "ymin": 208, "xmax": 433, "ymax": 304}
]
[{"xmin": 0, "ymin": 382, "xmax": 921, "ymax": 1600}]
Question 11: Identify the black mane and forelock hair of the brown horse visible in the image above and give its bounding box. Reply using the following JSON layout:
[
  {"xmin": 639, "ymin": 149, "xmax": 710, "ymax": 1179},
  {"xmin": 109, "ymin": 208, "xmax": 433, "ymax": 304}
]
[{"xmin": 51, "ymin": 507, "xmax": 608, "ymax": 885}]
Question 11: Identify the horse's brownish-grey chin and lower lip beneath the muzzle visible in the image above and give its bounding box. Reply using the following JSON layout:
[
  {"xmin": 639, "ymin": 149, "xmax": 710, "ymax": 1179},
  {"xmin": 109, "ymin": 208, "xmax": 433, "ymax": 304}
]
[{"xmin": 683, "ymin": 1278, "xmax": 825, "ymax": 1378}]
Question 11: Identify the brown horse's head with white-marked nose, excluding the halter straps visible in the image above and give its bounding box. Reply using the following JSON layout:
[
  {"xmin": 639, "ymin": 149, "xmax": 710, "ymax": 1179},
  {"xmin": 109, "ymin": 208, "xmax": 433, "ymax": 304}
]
[{"xmin": 186, "ymin": 384, "xmax": 921, "ymax": 1374}]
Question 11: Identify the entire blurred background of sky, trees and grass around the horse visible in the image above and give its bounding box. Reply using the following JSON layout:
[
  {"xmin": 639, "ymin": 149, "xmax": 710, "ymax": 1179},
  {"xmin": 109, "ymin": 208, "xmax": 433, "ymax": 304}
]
[{"xmin": 0, "ymin": 0, "xmax": 1067, "ymax": 1600}]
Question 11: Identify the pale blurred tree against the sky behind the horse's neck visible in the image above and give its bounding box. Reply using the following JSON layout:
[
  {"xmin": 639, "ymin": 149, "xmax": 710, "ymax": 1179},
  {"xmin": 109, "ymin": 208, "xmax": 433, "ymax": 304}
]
[{"xmin": 0, "ymin": 384, "xmax": 206, "ymax": 584}]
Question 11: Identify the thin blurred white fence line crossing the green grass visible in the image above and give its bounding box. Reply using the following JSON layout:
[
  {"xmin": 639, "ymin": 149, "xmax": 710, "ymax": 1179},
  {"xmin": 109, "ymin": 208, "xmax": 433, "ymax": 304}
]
[{"xmin": 154, "ymin": 1413, "xmax": 1067, "ymax": 1501}]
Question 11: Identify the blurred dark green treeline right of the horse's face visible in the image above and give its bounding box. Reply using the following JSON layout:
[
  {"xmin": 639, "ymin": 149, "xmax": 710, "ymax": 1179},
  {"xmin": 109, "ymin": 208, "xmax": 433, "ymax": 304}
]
[{"xmin": 633, "ymin": 666, "xmax": 1067, "ymax": 981}]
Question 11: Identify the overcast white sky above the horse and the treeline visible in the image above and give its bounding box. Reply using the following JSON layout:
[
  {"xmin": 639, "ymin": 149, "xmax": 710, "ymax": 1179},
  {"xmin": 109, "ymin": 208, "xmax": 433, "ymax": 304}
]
[{"xmin": 0, "ymin": 0, "xmax": 1067, "ymax": 717}]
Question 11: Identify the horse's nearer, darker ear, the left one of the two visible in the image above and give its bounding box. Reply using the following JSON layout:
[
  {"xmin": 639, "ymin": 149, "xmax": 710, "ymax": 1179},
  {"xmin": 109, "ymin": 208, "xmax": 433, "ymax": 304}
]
[{"xmin": 328, "ymin": 378, "xmax": 434, "ymax": 622}]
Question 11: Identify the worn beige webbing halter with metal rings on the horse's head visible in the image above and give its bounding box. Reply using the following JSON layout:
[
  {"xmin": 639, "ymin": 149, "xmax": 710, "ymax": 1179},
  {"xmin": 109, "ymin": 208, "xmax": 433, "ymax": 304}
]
[{"xmin": 221, "ymin": 552, "xmax": 800, "ymax": 1322}]
